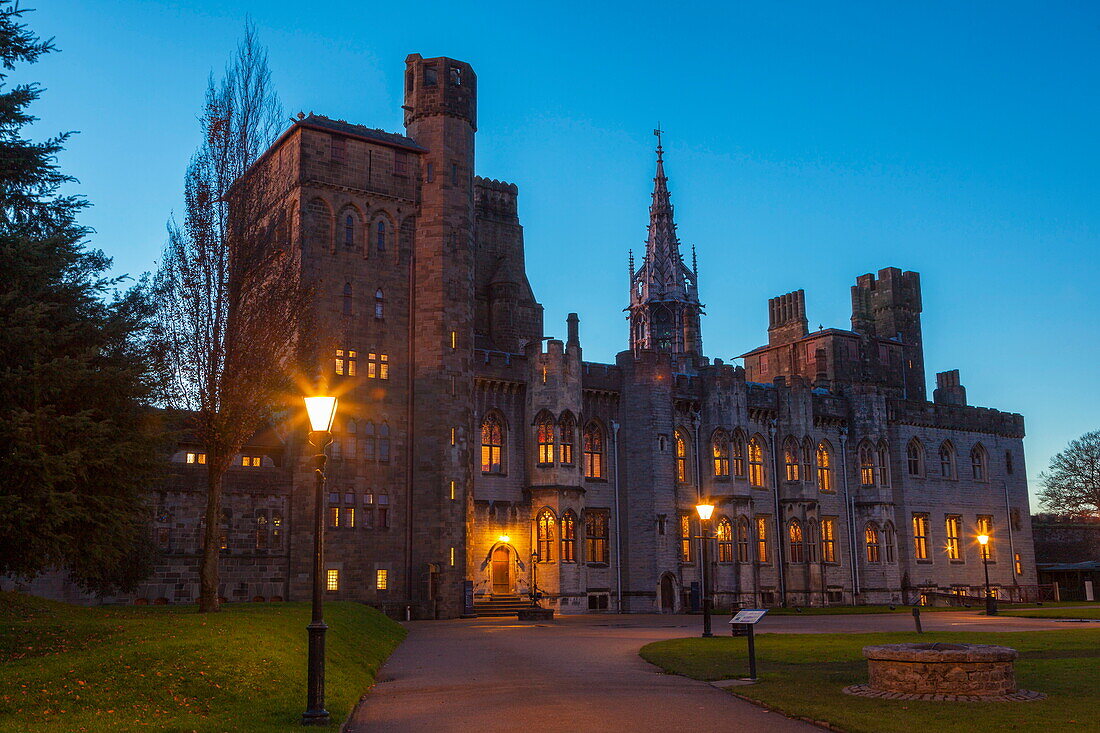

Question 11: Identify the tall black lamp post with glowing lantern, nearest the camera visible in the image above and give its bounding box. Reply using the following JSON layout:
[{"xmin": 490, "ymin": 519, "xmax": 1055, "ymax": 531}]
[{"xmin": 301, "ymin": 396, "xmax": 337, "ymax": 725}]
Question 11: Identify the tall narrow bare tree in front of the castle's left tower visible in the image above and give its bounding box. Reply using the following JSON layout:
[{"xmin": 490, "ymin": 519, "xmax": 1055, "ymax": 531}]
[{"xmin": 155, "ymin": 22, "xmax": 301, "ymax": 612}]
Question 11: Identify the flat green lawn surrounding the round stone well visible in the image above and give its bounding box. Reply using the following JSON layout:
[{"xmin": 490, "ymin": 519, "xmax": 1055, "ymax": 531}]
[{"xmin": 640, "ymin": 630, "xmax": 1100, "ymax": 733}]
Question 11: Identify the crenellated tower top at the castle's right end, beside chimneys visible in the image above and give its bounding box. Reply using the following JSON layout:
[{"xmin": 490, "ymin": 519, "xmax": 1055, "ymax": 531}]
[{"xmin": 851, "ymin": 267, "xmax": 927, "ymax": 401}]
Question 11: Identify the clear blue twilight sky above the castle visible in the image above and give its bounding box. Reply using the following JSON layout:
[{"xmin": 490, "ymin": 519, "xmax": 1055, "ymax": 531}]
[{"xmin": 13, "ymin": 0, "xmax": 1100, "ymax": 501}]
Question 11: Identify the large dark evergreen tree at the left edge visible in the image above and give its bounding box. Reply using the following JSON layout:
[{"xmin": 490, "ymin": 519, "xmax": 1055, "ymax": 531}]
[{"xmin": 0, "ymin": 0, "xmax": 161, "ymax": 593}]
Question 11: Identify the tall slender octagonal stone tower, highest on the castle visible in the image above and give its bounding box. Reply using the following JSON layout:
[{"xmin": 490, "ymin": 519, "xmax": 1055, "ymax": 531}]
[{"xmin": 405, "ymin": 54, "xmax": 477, "ymax": 616}]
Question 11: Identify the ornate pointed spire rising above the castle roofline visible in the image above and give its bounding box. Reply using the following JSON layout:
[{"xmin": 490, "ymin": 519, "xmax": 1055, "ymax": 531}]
[{"xmin": 628, "ymin": 130, "xmax": 703, "ymax": 364}]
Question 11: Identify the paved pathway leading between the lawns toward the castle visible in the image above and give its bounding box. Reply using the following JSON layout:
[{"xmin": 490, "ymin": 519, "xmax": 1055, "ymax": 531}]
[{"xmin": 349, "ymin": 611, "xmax": 1100, "ymax": 733}]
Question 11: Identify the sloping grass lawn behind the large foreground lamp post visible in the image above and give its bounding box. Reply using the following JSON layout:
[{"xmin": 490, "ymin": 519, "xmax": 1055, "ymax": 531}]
[{"xmin": 0, "ymin": 593, "xmax": 406, "ymax": 733}]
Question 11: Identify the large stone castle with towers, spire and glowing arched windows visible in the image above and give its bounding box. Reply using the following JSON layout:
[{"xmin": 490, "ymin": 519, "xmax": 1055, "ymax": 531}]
[{"xmin": 12, "ymin": 54, "xmax": 1036, "ymax": 617}]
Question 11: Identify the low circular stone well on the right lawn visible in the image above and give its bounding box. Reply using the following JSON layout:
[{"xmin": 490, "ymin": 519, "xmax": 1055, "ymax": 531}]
[{"xmin": 859, "ymin": 644, "xmax": 1022, "ymax": 699}]
